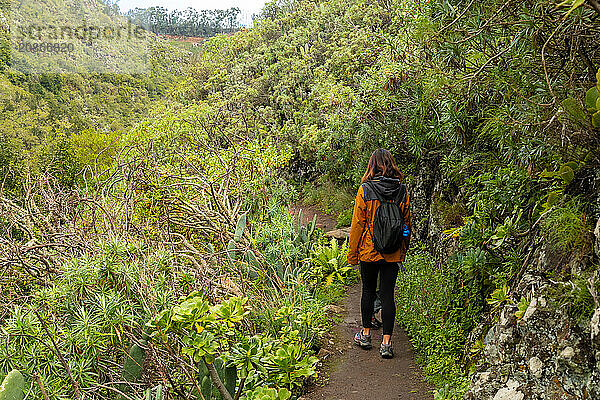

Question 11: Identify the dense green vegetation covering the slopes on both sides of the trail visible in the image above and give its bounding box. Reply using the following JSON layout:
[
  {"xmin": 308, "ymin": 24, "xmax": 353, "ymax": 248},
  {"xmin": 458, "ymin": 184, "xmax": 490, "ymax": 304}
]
[{"xmin": 0, "ymin": 0, "xmax": 600, "ymax": 399}]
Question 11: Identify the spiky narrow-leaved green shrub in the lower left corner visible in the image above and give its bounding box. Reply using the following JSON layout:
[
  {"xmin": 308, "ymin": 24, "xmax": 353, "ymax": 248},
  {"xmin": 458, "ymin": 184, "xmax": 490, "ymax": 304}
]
[{"xmin": 0, "ymin": 240, "xmax": 176, "ymax": 400}]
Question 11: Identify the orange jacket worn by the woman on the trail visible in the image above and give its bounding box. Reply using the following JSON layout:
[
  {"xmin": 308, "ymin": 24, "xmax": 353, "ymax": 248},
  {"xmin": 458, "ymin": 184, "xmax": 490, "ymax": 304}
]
[{"xmin": 348, "ymin": 179, "xmax": 412, "ymax": 265}]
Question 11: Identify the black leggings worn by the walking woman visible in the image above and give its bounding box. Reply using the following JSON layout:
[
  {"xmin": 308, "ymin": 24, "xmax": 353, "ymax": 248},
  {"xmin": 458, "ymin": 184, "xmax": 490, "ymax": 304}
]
[{"xmin": 360, "ymin": 261, "xmax": 399, "ymax": 335}]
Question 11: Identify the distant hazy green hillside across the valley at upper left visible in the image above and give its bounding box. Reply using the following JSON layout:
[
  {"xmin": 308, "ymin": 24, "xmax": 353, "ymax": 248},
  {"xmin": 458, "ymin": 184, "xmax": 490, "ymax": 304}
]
[{"xmin": 0, "ymin": 0, "xmax": 186, "ymax": 190}]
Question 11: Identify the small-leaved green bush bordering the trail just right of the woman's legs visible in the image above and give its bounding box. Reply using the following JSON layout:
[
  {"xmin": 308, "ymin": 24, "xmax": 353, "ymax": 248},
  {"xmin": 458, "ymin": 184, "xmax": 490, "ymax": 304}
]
[{"xmin": 396, "ymin": 245, "xmax": 483, "ymax": 399}]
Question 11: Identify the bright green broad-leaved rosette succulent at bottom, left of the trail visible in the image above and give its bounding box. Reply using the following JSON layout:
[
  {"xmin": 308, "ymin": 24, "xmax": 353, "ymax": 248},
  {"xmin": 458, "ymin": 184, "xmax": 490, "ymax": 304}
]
[{"xmin": 153, "ymin": 292, "xmax": 318, "ymax": 392}]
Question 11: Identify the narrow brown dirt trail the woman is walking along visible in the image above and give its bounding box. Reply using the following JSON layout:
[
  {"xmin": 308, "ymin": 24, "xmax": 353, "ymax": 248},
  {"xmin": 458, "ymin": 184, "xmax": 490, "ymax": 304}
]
[{"xmin": 290, "ymin": 204, "xmax": 433, "ymax": 400}]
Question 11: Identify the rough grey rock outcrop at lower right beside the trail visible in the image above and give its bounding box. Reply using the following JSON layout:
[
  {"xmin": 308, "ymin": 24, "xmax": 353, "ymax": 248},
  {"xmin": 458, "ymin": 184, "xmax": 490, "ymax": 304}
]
[{"xmin": 465, "ymin": 236, "xmax": 600, "ymax": 400}]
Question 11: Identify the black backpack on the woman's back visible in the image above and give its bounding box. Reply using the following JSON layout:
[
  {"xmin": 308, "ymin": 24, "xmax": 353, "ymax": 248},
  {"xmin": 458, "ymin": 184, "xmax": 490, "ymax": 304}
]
[{"xmin": 367, "ymin": 182, "xmax": 410, "ymax": 254}]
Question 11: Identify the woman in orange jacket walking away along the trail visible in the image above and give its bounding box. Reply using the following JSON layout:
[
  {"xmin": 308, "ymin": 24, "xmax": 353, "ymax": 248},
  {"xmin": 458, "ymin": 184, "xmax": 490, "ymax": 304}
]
[{"xmin": 348, "ymin": 149, "xmax": 411, "ymax": 358}]
